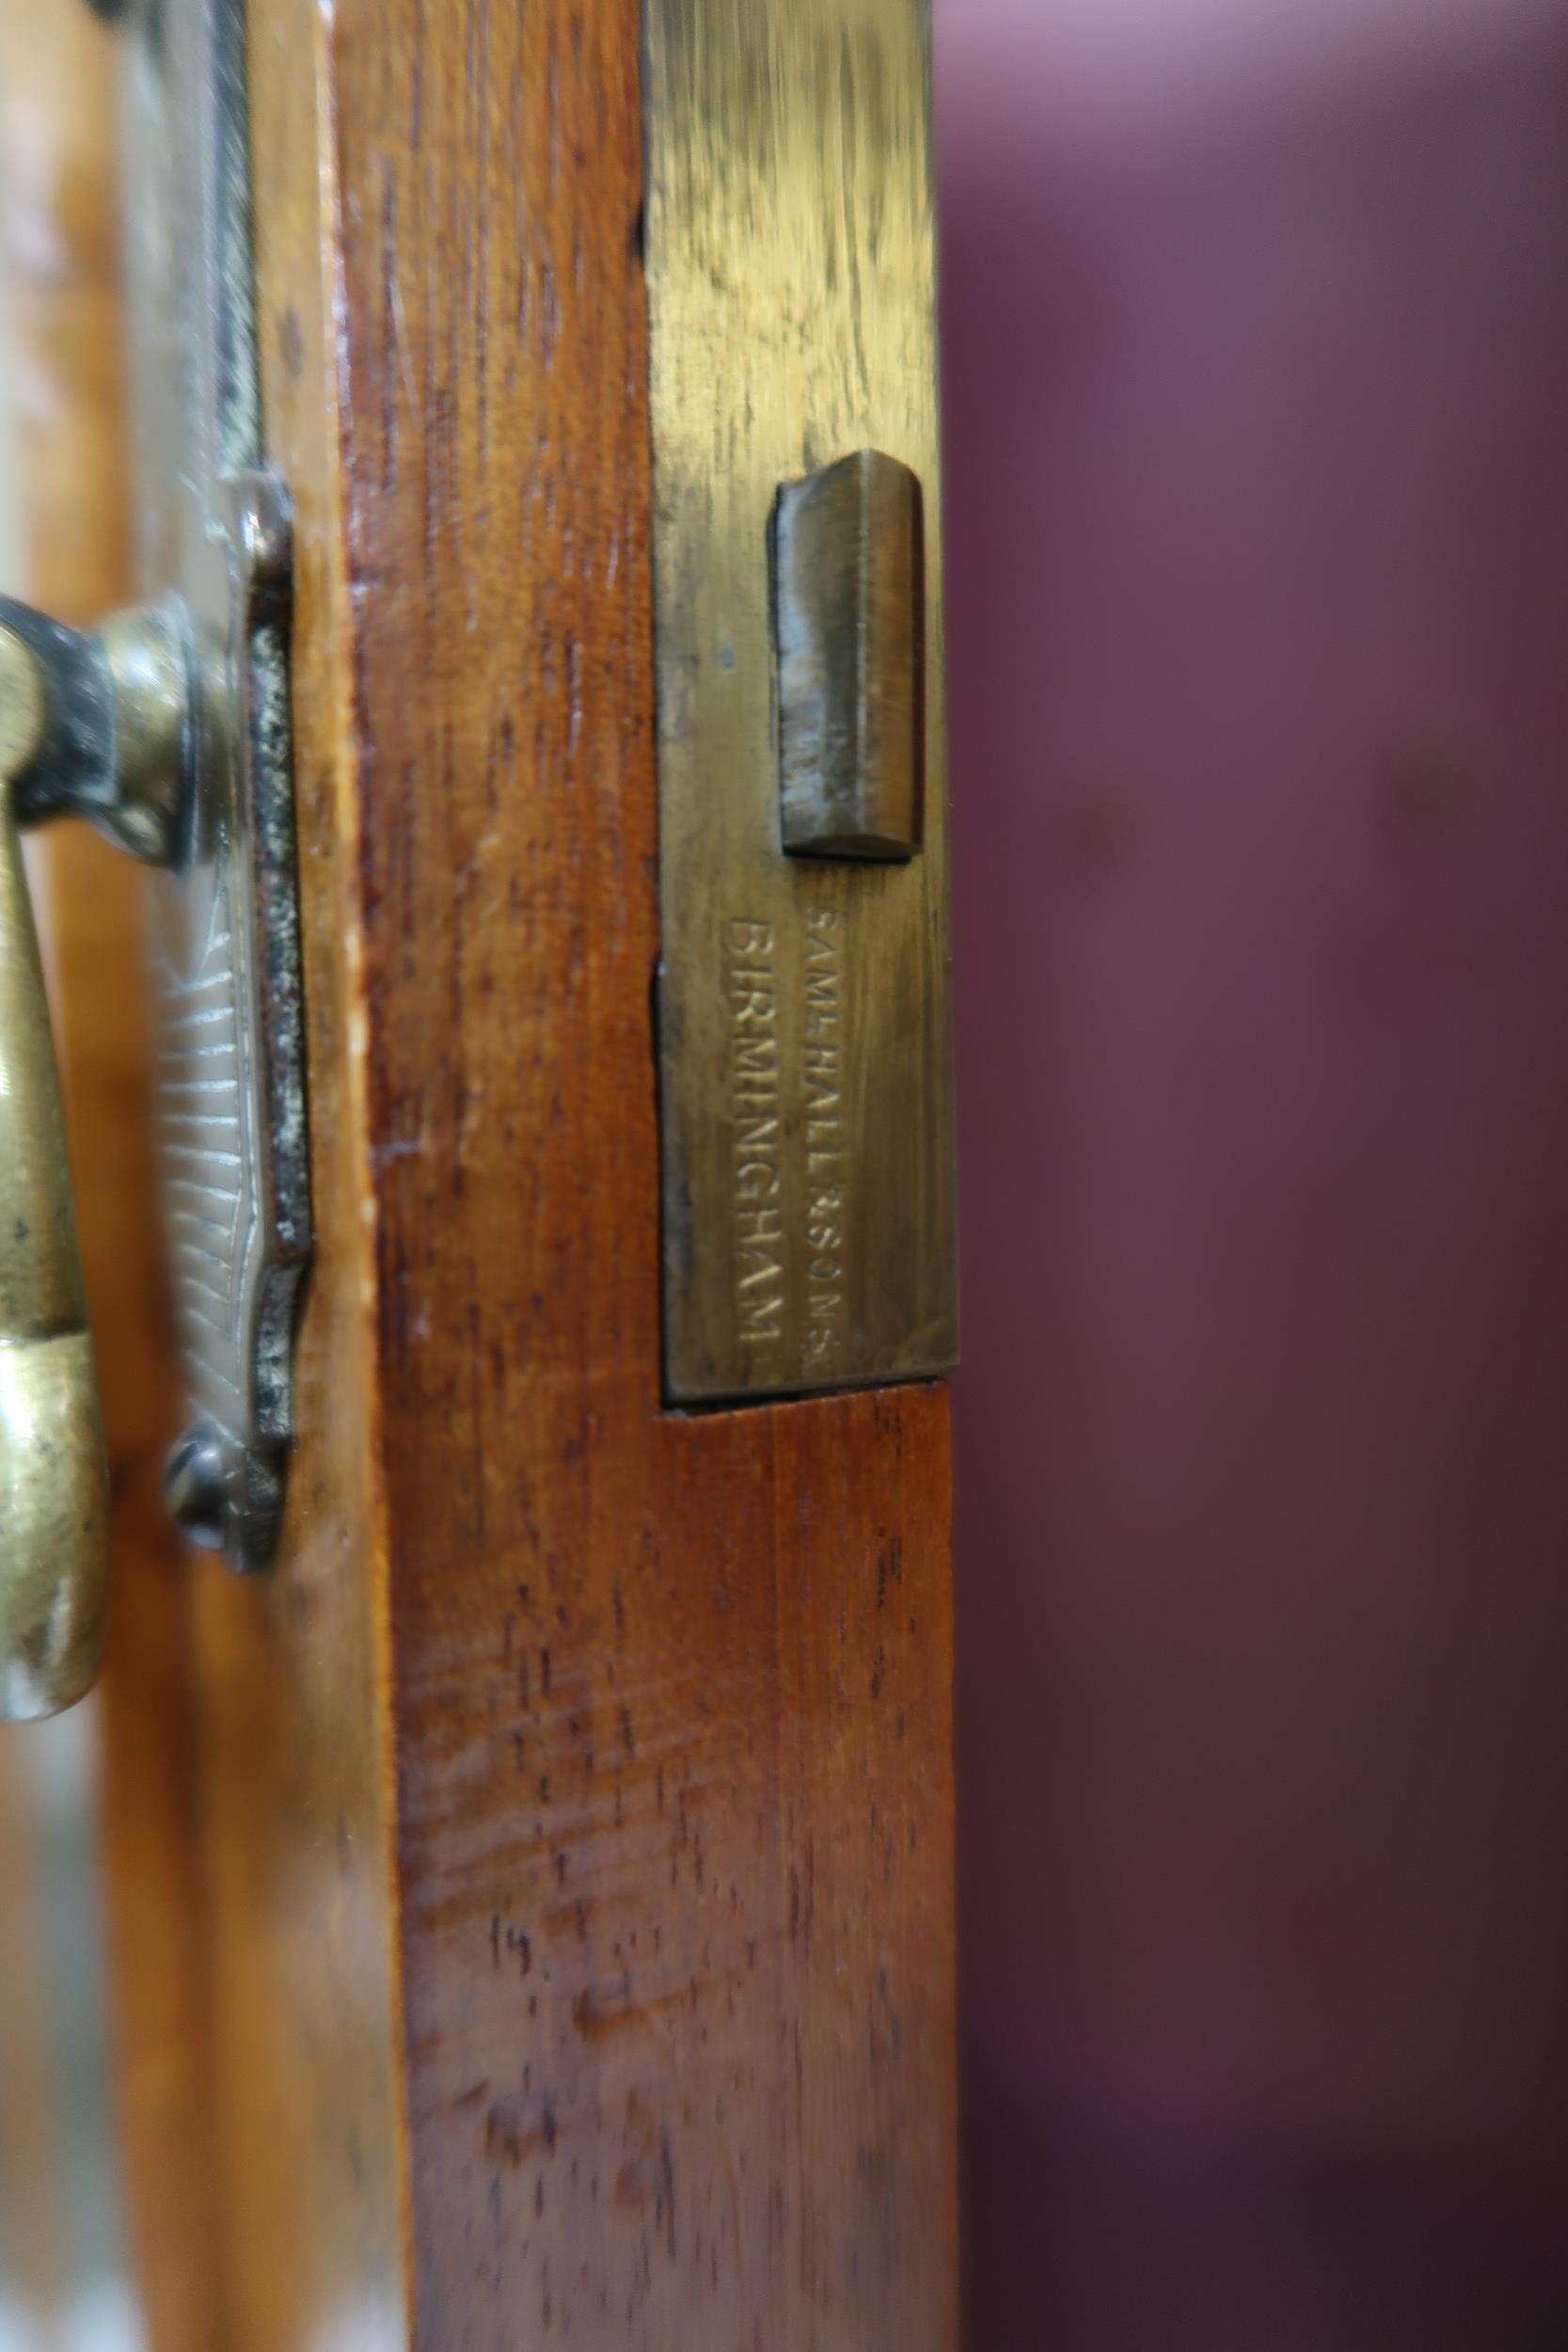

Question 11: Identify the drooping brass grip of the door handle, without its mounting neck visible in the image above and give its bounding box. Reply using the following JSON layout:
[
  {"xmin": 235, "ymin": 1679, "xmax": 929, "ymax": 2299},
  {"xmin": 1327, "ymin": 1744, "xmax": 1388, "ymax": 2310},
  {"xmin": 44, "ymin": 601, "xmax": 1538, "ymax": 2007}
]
[{"xmin": 0, "ymin": 621, "xmax": 108, "ymax": 1722}]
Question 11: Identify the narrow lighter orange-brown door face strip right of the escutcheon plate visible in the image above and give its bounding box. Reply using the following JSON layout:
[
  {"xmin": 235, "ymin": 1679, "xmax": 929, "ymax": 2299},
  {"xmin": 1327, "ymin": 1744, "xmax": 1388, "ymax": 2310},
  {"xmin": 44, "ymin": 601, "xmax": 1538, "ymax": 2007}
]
[{"xmin": 181, "ymin": 0, "xmax": 409, "ymax": 2352}]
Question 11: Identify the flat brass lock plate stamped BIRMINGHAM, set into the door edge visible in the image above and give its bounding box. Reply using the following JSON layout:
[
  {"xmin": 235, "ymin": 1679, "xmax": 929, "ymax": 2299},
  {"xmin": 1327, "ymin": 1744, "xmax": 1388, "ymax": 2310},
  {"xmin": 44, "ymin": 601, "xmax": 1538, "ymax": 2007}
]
[{"xmin": 646, "ymin": 0, "xmax": 957, "ymax": 1402}]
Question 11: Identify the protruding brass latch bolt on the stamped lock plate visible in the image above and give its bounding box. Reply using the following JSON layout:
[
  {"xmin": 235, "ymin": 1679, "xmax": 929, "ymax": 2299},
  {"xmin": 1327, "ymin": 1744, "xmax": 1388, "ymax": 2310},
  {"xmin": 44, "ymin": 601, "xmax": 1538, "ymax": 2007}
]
[{"xmin": 773, "ymin": 450, "xmax": 927, "ymax": 859}]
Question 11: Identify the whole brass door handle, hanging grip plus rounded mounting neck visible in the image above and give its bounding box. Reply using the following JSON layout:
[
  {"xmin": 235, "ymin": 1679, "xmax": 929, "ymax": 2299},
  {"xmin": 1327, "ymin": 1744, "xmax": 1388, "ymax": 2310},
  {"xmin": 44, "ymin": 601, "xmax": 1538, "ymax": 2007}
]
[{"xmin": 0, "ymin": 600, "xmax": 185, "ymax": 1722}]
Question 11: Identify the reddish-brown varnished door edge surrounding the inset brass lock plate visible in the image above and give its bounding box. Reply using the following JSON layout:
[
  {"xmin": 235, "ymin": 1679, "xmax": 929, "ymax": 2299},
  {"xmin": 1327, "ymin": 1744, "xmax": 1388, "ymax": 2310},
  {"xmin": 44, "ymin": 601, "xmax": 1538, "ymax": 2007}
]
[{"xmin": 303, "ymin": 0, "xmax": 955, "ymax": 2352}]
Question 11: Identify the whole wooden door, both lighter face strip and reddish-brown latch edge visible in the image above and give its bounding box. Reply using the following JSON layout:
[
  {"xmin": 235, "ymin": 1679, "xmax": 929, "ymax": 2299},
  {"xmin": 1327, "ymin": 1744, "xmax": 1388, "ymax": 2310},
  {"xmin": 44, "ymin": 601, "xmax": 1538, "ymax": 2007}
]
[{"xmin": 3, "ymin": 0, "xmax": 957, "ymax": 2352}]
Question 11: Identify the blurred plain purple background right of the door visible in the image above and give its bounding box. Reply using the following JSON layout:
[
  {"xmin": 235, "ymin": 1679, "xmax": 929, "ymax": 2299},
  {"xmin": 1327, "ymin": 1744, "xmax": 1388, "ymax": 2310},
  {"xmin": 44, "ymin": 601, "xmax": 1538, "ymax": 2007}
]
[{"xmin": 938, "ymin": 0, "xmax": 1568, "ymax": 2352}]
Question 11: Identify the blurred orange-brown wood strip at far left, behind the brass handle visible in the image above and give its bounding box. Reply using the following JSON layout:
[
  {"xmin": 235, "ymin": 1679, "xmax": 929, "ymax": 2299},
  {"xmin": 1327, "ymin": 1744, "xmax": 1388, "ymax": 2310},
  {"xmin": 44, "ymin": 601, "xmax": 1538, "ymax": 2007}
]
[{"xmin": 0, "ymin": 0, "xmax": 223, "ymax": 2352}]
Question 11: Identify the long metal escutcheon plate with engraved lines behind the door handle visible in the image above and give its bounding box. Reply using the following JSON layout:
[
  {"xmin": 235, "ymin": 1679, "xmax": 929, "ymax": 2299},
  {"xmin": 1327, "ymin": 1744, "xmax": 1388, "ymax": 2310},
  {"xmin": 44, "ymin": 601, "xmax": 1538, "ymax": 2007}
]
[{"xmin": 122, "ymin": 0, "xmax": 310, "ymax": 1569}]
